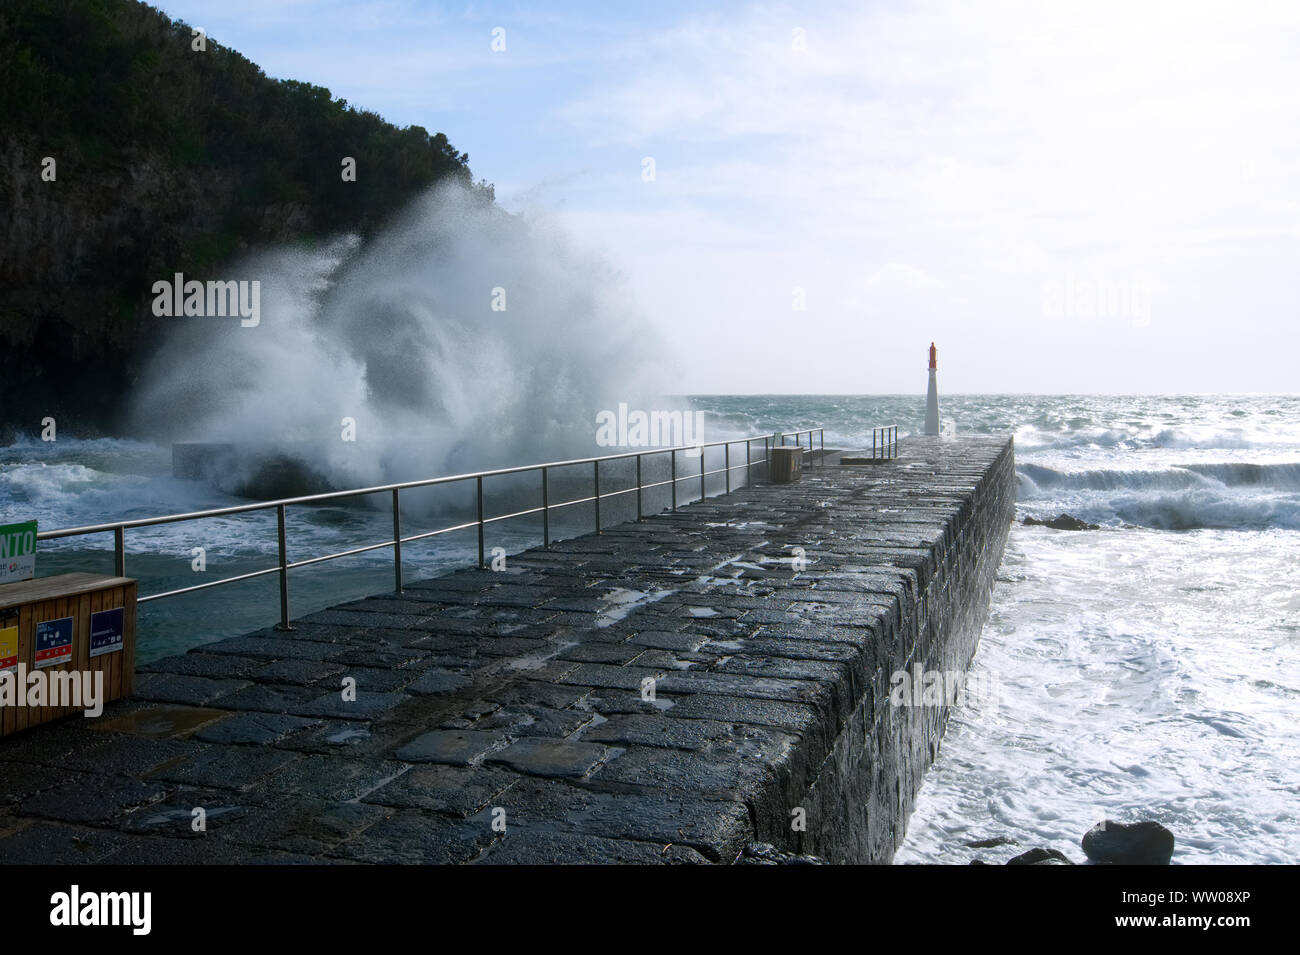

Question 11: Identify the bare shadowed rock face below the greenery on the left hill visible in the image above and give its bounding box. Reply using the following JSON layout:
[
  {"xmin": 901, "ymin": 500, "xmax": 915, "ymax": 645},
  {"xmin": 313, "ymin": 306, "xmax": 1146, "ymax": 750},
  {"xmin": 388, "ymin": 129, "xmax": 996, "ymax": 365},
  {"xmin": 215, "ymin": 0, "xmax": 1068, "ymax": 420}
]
[{"xmin": 0, "ymin": 138, "xmax": 235, "ymax": 434}]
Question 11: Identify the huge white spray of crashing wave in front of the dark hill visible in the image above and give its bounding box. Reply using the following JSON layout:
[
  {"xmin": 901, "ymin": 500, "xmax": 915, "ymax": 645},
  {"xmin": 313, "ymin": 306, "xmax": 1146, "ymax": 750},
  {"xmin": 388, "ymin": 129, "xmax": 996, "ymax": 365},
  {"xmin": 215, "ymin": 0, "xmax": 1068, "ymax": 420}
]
[{"xmin": 133, "ymin": 186, "xmax": 684, "ymax": 487}]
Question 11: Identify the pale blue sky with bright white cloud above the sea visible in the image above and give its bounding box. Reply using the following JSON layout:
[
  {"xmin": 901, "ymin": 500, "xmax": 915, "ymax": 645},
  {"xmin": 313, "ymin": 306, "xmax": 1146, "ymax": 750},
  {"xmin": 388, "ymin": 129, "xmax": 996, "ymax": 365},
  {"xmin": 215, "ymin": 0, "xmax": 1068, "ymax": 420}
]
[{"xmin": 159, "ymin": 0, "xmax": 1300, "ymax": 394}]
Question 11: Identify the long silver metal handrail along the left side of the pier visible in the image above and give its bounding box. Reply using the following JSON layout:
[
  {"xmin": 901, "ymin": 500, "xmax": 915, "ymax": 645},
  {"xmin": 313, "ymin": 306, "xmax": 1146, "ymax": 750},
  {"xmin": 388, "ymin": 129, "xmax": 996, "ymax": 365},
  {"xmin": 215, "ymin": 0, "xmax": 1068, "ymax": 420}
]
[{"xmin": 36, "ymin": 429, "xmax": 826, "ymax": 630}]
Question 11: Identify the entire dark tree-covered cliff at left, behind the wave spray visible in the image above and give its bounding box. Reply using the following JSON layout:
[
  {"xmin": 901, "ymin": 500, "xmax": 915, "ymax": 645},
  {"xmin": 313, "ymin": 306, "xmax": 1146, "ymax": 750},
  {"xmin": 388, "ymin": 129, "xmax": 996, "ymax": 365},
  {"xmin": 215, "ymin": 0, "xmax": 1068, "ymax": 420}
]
[{"xmin": 0, "ymin": 0, "xmax": 491, "ymax": 439}]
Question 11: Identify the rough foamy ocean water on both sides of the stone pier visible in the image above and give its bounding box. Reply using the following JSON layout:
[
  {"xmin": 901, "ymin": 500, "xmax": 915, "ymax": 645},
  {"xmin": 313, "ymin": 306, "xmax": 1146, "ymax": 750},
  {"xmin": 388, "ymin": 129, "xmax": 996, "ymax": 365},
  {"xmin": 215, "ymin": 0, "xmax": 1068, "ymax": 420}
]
[{"xmin": 0, "ymin": 395, "xmax": 1300, "ymax": 864}]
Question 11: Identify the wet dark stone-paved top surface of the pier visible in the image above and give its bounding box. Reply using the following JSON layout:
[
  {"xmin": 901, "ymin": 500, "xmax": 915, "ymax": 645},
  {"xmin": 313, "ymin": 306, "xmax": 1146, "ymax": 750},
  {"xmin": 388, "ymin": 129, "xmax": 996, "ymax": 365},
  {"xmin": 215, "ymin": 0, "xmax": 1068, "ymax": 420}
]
[{"xmin": 0, "ymin": 438, "xmax": 1010, "ymax": 864}]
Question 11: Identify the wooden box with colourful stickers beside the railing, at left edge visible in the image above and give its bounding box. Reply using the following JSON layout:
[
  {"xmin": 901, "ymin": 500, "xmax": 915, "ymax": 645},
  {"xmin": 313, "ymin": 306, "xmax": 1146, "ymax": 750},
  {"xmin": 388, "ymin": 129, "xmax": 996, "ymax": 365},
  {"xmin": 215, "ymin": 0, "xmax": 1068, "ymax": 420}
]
[{"xmin": 0, "ymin": 573, "xmax": 137, "ymax": 737}]
